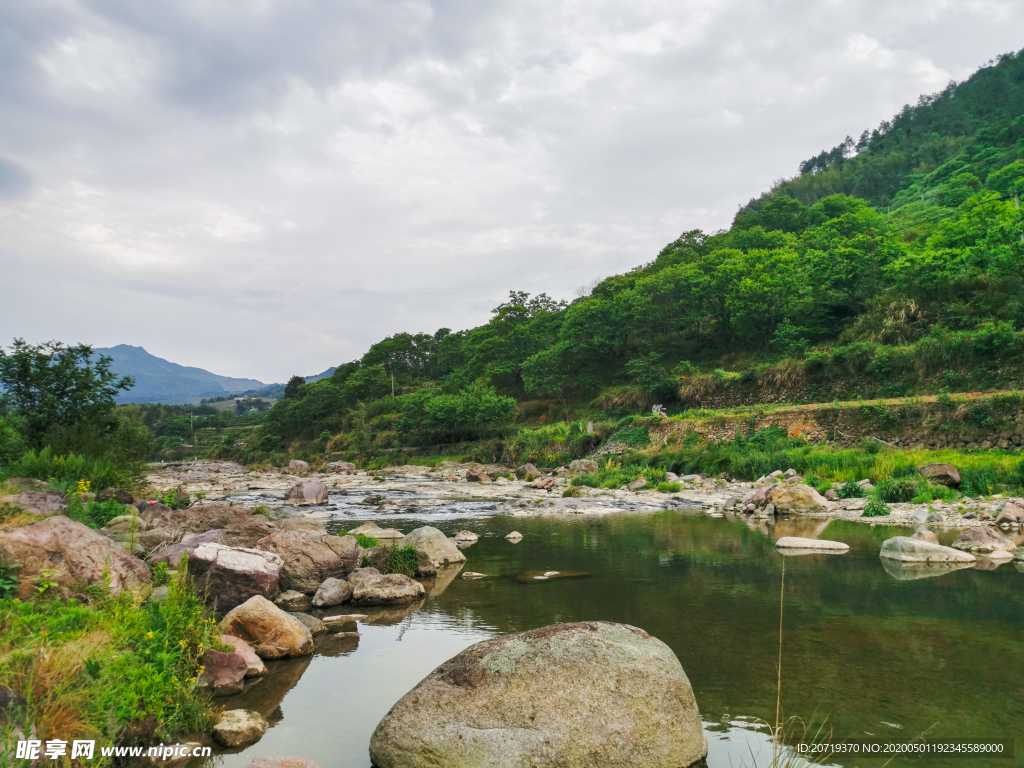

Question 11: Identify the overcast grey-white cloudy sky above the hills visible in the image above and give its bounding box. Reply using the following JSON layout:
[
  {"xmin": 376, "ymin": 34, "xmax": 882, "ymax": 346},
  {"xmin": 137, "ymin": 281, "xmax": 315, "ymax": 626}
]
[{"xmin": 0, "ymin": 0, "xmax": 1024, "ymax": 382}]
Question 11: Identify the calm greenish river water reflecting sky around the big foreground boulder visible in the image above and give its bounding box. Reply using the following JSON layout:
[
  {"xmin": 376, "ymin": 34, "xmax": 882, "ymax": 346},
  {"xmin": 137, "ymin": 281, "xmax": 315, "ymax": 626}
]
[{"xmin": 201, "ymin": 507, "xmax": 1024, "ymax": 768}]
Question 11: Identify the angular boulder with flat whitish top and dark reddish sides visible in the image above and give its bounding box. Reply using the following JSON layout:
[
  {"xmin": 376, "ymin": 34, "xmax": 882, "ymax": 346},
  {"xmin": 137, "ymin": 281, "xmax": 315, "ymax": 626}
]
[{"xmin": 188, "ymin": 544, "xmax": 285, "ymax": 613}]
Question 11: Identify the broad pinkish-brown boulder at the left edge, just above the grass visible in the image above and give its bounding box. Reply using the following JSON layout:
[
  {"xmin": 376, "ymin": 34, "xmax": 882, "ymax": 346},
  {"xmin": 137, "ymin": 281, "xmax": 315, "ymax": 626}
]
[{"xmin": 0, "ymin": 516, "xmax": 150, "ymax": 598}]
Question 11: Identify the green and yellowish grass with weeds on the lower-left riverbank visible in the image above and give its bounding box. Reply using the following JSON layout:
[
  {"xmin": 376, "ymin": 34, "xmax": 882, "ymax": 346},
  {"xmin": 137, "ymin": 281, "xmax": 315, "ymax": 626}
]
[{"xmin": 0, "ymin": 567, "xmax": 216, "ymax": 766}]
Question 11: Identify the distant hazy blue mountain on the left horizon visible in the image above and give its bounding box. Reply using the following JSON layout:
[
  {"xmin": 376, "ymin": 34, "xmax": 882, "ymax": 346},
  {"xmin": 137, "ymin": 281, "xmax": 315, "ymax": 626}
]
[{"xmin": 94, "ymin": 344, "xmax": 265, "ymax": 402}]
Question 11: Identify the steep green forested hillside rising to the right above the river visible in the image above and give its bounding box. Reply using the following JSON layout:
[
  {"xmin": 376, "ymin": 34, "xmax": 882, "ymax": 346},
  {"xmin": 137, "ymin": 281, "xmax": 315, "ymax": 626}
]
[{"xmin": 246, "ymin": 51, "xmax": 1024, "ymax": 460}]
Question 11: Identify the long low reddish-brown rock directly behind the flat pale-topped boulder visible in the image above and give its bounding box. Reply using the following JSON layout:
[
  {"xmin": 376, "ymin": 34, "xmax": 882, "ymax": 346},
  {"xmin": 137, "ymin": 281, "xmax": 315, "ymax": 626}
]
[{"xmin": 138, "ymin": 504, "xmax": 278, "ymax": 552}]
